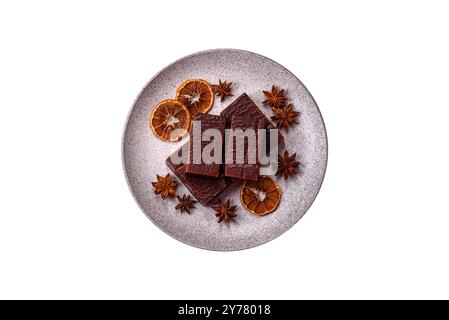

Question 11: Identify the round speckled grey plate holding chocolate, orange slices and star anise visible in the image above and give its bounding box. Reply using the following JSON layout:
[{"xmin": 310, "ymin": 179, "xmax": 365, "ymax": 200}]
[{"xmin": 123, "ymin": 49, "xmax": 327, "ymax": 251}]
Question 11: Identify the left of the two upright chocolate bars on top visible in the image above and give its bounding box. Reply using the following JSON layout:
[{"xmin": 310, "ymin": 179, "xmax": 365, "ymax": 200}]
[{"xmin": 186, "ymin": 113, "xmax": 226, "ymax": 177}]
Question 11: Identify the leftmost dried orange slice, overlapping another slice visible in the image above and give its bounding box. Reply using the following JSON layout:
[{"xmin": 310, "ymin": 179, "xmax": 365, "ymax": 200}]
[{"xmin": 150, "ymin": 99, "xmax": 190, "ymax": 142}]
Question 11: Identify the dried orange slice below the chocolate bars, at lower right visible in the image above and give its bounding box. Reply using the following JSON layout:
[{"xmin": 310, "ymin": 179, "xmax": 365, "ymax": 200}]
[{"xmin": 240, "ymin": 176, "xmax": 282, "ymax": 216}]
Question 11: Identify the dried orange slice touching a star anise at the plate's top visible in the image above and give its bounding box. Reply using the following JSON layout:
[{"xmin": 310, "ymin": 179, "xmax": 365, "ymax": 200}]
[{"xmin": 176, "ymin": 79, "xmax": 214, "ymax": 118}]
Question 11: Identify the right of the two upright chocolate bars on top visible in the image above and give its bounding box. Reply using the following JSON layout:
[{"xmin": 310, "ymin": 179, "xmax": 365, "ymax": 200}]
[{"xmin": 225, "ymin": 115, "xmax": 264, "ymax": 181}]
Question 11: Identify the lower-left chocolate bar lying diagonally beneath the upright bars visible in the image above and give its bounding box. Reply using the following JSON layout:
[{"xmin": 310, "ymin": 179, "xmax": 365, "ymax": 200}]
[{"xmin": 165, "ymin": 148, "xmax": 232, "ymax": 207}]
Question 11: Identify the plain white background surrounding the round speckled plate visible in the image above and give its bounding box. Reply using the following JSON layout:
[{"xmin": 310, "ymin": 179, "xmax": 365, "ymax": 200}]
[{"xmin": 0, "ymin": 0, "xmax": 449, "ymax": 299}]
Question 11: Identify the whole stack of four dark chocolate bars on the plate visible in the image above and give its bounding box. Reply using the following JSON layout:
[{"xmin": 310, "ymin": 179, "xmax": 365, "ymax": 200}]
[{"xmin": 166, "ymin": 93, "xmax": 283, "ymax": 206}]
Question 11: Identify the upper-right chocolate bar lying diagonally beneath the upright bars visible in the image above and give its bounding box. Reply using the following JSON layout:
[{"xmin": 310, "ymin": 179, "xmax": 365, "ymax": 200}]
[{"xmin": 220, "ymin": 93, "xmax": 284, "ymax": 151}]
